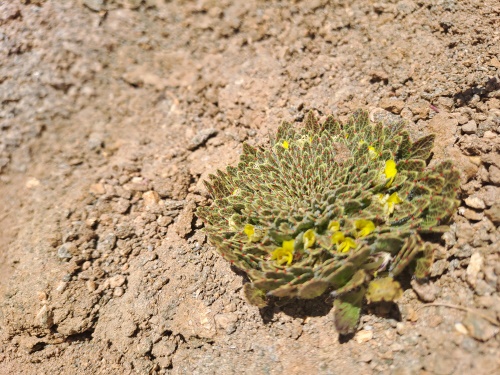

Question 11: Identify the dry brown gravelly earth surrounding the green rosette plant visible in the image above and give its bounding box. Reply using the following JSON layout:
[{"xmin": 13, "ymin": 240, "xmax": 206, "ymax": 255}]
[{"xmin": 0, "ymin": 0, "xmax": 500, "ymax": 375}]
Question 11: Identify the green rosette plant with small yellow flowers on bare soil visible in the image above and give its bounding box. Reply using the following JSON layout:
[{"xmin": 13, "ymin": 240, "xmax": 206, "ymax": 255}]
[{"xmin": 197, "ymin": 111, "xmax": 459, "ymax": 334}]
